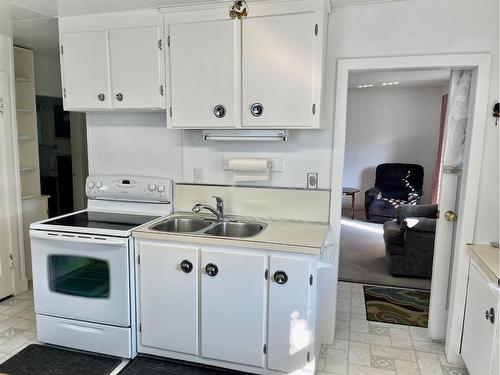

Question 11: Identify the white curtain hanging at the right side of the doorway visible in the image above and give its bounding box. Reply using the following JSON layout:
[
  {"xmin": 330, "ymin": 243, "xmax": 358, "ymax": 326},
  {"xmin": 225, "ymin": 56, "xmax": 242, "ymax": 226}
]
[{"xmin": 443, "ymin": 70, "xmax": 472, "ymax": 173}]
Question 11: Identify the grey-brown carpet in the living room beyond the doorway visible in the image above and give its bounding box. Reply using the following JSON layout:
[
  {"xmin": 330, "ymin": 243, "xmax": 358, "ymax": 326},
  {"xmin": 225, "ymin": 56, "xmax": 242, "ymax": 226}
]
[{"xmin": 339, "ymin": 211, "xmax": 431, "ymax": 289}]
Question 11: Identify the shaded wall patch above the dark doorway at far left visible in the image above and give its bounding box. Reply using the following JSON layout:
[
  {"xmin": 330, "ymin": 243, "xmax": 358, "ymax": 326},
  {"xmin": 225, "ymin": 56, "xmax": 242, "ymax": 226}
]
[{"xmin": 33, "ymin": 50, "xmax": 62, "ymax": 98}]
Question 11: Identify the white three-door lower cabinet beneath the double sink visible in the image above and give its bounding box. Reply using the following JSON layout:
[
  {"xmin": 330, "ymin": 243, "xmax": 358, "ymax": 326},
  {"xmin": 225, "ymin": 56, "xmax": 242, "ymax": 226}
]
[{"xmin": 135, "ymin": 238, "xmax": 316, "ymax": 375}]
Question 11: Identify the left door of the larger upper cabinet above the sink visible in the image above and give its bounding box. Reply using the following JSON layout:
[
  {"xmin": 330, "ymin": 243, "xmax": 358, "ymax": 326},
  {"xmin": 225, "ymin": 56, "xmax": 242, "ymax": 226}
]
[{"xmin": 168, "ymin": 19, "xmax": 240, "ymax": 128}]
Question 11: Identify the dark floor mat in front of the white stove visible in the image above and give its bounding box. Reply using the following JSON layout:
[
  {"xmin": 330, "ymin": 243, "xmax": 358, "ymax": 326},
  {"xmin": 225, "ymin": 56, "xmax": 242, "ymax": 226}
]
[{"xmin": 0, "ymin": 344, "xmax": 121, "ymax": 375}]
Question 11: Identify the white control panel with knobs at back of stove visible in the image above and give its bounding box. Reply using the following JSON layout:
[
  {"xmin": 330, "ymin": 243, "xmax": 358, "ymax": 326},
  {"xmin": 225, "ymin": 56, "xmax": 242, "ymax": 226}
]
[{"xmin": 85, "ymin": 175, "xmax": 173, "ymax": 203}]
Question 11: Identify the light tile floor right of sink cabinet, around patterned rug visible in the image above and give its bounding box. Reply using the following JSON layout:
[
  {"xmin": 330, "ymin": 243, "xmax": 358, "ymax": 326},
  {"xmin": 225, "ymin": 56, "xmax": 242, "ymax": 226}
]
[{"xmin": 318, "ymin": 282, "xmax": 468, "ymax": 375}]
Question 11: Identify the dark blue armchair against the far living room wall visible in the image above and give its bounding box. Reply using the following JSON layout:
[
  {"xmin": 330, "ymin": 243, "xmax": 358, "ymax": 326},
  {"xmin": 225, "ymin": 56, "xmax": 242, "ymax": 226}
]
[{"xmin": 365, "ymin": 163, "xmax": 424, "ymax": 223}]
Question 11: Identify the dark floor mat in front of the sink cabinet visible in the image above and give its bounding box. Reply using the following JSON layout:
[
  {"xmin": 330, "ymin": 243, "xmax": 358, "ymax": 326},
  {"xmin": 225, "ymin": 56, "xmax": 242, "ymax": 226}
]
[{"xmin": 119, "ymin": 355, "xmax": 247, "ymax": 375}]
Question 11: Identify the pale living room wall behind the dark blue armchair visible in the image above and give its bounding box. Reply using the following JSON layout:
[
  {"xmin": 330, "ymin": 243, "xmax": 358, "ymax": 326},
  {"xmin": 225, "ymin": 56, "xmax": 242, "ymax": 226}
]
[{"xmin": 343, "ymin": 87, "xmax": 441, "ymax": 207}]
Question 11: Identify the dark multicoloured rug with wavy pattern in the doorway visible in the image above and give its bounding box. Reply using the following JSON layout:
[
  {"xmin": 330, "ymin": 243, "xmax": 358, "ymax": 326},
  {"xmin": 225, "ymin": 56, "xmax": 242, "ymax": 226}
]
[{"xmin": 364, "ymin": 285, "xmax": 431, "ymax": 327}]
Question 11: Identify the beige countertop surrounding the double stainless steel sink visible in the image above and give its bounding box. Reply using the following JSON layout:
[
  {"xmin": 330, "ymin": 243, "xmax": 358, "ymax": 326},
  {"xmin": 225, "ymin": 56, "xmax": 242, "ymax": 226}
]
[{"xmin": 132, "ymin": 212, "xmax": 330, "ymax": 255}]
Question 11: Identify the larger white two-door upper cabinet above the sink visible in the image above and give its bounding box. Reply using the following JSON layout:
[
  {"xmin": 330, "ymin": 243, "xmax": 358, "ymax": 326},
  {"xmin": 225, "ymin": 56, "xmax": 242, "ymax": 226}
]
[{"xmin": 165, "ymin": 0, "xmax": 329, "ymax": 129}]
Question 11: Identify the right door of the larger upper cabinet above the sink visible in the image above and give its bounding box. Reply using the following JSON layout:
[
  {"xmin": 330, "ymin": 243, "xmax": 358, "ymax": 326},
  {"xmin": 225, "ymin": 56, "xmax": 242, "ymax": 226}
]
[{"xmin": 241, "ymin": 12, "xmax": 320, "ymax": 128}]
